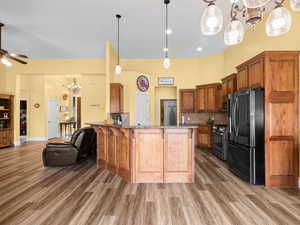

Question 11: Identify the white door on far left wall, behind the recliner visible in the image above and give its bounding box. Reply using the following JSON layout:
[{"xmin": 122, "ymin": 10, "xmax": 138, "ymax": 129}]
[{"xmin": 48, "ymin": 99, "xmax": 59, "ymax": 139}]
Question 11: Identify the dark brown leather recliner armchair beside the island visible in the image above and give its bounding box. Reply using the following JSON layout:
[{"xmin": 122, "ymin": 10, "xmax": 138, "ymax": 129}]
[{"xmin": 43, "ymin": 127, "xmax": 96, "ymax": 167}]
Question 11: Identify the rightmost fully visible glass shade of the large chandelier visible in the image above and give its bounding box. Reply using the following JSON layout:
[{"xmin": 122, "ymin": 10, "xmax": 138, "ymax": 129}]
[{"xmin": 266, "ymin": 1, "xmax": 292, "ymax": 37}]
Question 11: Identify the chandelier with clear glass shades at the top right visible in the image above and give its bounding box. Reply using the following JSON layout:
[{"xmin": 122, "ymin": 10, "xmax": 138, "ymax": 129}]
[{"xmin": 201, "ymin": 0, "xmax": 300, "ymax": 46}]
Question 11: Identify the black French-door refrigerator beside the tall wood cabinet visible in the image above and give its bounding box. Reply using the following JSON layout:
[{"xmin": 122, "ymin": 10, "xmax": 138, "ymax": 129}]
[{"xmin": 227, "ymin": 88, "xmax": 265, "ymax": 185}]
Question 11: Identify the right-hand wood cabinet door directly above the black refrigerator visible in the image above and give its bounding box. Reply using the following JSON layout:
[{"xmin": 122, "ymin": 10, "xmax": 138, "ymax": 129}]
[{"xmin": 248, "ymin": 59, "xmax": 264, "ymax": 88}]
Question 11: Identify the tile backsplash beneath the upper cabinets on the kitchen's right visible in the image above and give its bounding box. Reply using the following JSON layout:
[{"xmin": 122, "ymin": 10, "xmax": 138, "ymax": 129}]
[{"xmin": 180, "ymin": 113, "xmax": 227, "ymax": 125}]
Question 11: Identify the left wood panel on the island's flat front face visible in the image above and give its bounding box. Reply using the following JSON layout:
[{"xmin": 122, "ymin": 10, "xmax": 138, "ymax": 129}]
[{"xmin": 133, "ymin": 129, "xmax": 164, "ymax": 183}]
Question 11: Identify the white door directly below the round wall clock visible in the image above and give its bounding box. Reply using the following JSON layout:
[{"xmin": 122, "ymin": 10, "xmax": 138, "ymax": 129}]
[{"xmin": 136, "ymin": 93, "xmax": 150, "ymax": 126}]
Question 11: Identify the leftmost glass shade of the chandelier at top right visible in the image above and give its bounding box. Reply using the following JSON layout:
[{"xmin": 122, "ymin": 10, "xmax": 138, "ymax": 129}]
[{"xmin": 201, "ymin": 0, "xmax": 223, "ymax": 35}]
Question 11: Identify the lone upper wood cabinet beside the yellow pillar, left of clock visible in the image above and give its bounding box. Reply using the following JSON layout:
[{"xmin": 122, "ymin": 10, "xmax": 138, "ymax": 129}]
[{"xmin": 110, "ymin": 83, "xmax": 123, "ymax": 113}]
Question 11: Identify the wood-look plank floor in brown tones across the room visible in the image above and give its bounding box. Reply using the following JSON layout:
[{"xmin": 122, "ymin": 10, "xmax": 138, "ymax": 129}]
[{"xmin": 0, "ymin": 142, "xmax": 300, "ymax": 225}]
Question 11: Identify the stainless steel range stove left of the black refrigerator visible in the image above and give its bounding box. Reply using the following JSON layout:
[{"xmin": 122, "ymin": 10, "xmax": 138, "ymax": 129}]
[{"xmin": 212, "ymin": 124, "xmax": 228, "ymax": 161}]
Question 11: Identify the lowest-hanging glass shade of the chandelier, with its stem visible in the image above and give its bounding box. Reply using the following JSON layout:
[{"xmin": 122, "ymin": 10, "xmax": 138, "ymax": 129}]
[{"xmin": 224, "ymin": 4, "xmax": 245, "ymax": 46}]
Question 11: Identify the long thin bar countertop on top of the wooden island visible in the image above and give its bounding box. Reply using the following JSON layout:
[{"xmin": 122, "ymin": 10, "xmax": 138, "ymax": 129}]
[{"xmin": 87, "ymin": 122, "xmax": 198, "ymax": 129}]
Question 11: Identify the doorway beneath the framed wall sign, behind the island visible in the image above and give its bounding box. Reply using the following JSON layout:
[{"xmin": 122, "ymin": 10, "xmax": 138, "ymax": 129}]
[{"xmin": 160, "ymin": 99, "xmax": 177, "ymax": 126}]
